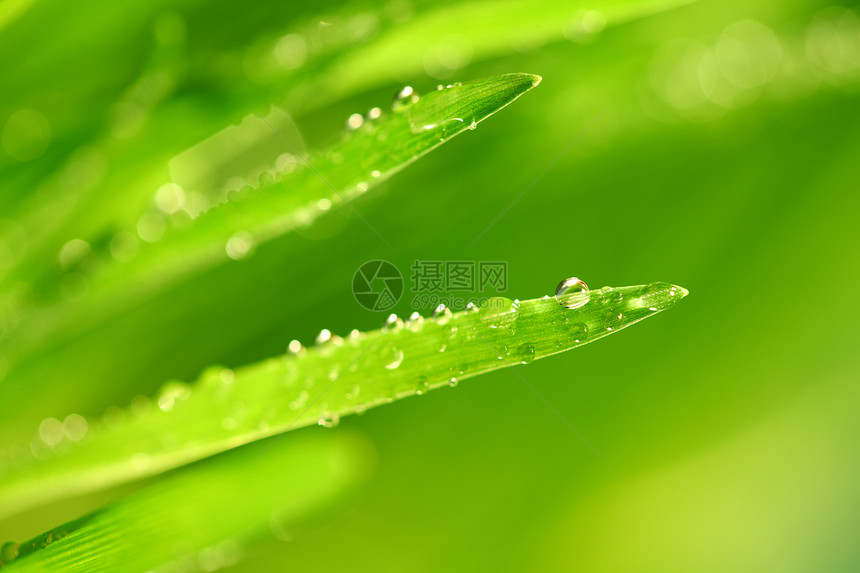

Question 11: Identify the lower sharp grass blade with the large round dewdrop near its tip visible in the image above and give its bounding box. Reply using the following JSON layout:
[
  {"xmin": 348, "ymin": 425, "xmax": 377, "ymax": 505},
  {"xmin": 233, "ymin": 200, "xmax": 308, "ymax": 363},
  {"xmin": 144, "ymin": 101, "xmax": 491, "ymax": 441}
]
[{"xmin": 0, "ymin": 283, "xmax": 687, "ymax": 515}]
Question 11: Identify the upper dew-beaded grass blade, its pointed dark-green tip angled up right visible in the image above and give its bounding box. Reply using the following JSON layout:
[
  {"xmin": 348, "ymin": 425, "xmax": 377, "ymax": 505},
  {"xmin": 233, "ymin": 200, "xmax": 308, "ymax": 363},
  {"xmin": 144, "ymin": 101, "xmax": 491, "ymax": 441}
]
[{"xmin": 7, "ymin": 73, "xmax": 540, "ymax": 360}]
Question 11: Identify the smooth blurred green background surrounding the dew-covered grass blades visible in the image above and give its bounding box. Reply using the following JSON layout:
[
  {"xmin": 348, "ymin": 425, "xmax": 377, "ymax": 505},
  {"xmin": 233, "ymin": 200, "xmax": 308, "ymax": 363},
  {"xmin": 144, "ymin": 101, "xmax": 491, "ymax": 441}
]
[{"xmin": 0, "ymin": 0, "xmax": 860, "ymax": 572}]
